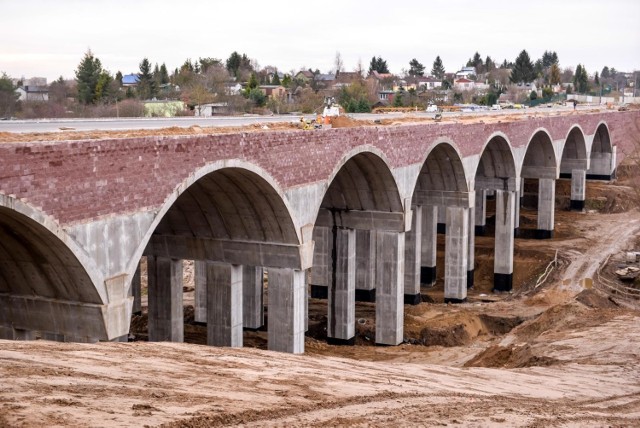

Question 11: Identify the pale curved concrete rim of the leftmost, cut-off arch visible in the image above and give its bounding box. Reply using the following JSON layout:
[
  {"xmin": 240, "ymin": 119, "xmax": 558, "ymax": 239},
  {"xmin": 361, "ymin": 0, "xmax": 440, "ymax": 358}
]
[{"xmin": 0, "ymin": 193, "xmax": 109, "ymax": 304}]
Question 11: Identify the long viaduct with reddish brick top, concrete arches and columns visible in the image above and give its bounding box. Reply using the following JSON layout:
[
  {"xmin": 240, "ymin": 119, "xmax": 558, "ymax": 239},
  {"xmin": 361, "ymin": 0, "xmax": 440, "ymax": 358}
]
[{"xmin": 0, "ymin": 112, "xmax": 640, "ymax": 353}]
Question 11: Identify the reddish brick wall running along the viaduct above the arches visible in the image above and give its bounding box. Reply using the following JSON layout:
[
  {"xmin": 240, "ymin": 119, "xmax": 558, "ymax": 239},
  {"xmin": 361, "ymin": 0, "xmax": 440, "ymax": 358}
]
[{"xmin": 0, "ymin": 108, "xmax": 640, "ymax": 224}]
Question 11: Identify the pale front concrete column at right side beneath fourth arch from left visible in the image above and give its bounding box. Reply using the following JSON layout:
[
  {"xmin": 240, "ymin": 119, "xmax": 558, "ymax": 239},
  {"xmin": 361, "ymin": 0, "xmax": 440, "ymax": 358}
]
[{"xmin": 444, "ymin": 207, "xmax": 469, "ymax": 303}]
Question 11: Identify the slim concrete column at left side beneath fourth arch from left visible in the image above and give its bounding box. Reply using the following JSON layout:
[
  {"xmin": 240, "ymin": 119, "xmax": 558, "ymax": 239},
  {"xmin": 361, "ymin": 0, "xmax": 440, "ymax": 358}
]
[{"xmin": 404, "ymin": 205, "xmax": 422, "ymax": 305}]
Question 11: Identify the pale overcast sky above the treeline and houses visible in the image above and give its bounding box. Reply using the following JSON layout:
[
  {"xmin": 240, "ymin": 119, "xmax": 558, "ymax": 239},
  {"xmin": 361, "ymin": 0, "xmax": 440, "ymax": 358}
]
[{"xmin": 0, "ymin": 0, "xmax": 640, "ymax": 81}]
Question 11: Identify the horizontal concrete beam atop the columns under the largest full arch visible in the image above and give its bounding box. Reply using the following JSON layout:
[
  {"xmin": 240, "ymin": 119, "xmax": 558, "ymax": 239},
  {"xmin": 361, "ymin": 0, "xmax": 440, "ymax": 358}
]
[{"xmin": 145, "ymin": 235, "xmax": 313, "ymax": 270}]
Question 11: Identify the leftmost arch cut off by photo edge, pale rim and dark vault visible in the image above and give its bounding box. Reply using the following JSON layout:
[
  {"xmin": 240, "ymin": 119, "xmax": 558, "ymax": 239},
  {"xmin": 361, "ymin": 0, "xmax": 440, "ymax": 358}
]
[{"xmin": 0, "ymin": 194, "xmax": 108, "ymax": 304}]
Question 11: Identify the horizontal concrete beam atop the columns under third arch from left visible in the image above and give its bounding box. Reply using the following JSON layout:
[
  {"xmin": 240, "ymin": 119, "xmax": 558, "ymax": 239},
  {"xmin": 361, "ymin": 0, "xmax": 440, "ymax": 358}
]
[{"xmin": 316, "ymin": 208, "xmax": 411, "ymax": 232}]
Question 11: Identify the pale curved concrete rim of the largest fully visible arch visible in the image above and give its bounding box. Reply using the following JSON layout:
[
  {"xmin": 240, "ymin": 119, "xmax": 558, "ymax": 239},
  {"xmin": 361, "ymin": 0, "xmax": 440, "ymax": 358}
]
[{"xmin": 127, "ymin": 159, "xmax": 302, "ymax": 277}]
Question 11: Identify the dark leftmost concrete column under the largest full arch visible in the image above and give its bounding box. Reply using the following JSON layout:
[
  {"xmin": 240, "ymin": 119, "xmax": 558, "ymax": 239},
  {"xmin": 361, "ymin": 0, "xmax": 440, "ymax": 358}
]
[{"xmin": 147, "ymin": 256, "xmax": 184, "ymax": 342}]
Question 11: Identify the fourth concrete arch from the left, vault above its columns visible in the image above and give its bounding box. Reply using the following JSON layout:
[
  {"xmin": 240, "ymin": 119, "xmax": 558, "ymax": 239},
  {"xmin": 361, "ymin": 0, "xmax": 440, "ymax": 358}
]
[{"xmin": 412, "ymin": 138, "xmax": 469, "ymax": 195}]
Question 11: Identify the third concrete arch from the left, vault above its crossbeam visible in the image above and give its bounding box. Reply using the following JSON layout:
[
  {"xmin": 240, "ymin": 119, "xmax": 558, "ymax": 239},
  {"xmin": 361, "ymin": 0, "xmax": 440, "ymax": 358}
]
[{"xmin": 320, "ymin": 145, "xmax": 403, "ymax": 212}]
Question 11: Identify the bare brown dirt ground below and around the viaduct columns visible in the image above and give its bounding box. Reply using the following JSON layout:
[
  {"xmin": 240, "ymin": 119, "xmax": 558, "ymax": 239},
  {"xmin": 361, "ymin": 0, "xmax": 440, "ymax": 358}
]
[{"xmin": 0, "ymin": 146, "xmax": 640, "ymax": 427}]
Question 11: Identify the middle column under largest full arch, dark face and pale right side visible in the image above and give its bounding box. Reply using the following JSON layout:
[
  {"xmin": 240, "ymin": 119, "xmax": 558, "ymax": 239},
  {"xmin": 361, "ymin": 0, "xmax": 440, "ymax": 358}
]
[{"xmin": 206, "ymin": 262, "xmax": 242, "ymax": 347}]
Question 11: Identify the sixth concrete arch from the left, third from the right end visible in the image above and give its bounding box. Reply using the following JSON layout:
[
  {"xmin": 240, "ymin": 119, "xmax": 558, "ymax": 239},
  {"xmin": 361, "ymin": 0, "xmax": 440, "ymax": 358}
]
[{"xmin": 519, "ymin": 128, "xmax": 558, "ymax": 179}]
